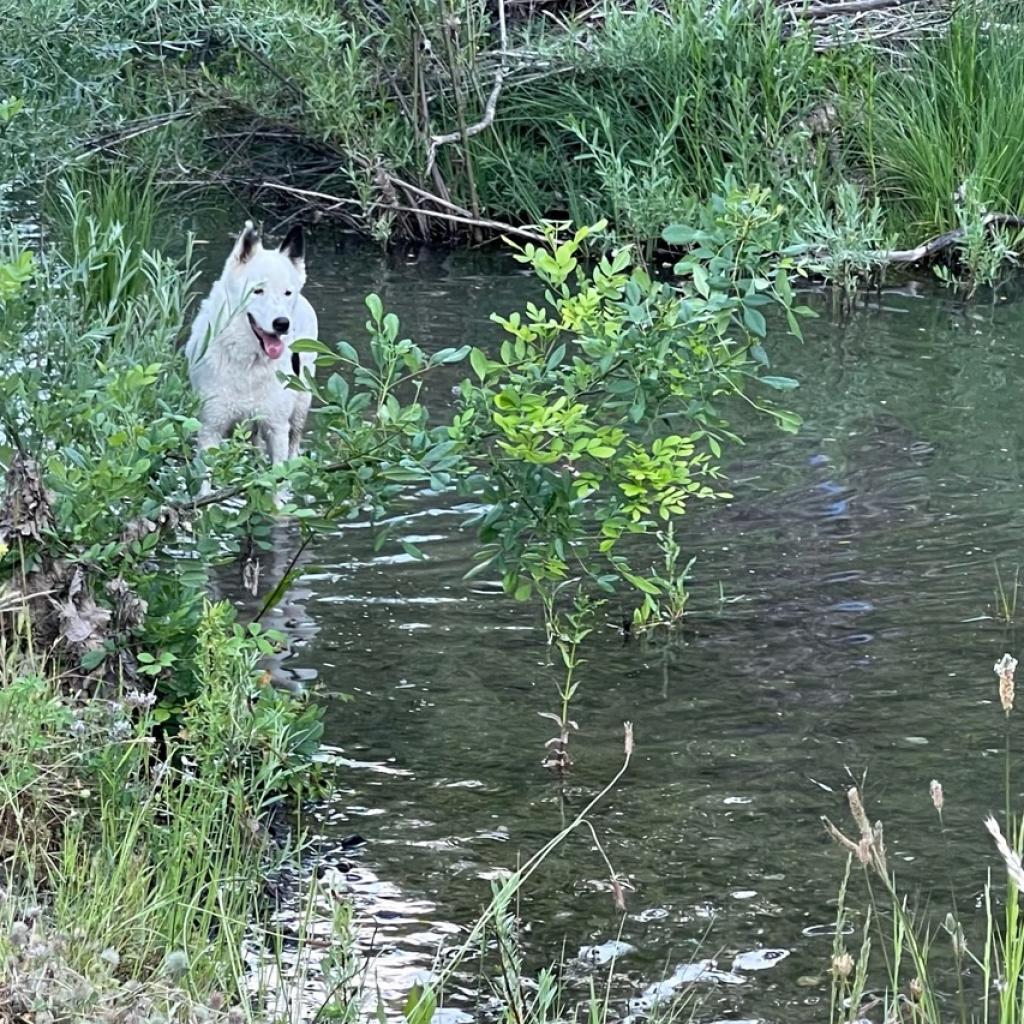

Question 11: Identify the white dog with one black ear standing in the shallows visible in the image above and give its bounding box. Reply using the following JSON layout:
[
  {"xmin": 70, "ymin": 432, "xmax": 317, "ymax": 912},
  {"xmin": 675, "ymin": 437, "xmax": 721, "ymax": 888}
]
[{"xmin": 185, "ymin": 221, "xmax": 317, "ymax": 465}]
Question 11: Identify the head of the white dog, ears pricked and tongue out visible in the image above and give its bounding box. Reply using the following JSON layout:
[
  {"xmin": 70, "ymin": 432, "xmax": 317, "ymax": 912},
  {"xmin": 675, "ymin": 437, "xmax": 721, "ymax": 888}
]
[{"xmin": 221, "ymin": 220, "xmax": 306, "ymax": 359}]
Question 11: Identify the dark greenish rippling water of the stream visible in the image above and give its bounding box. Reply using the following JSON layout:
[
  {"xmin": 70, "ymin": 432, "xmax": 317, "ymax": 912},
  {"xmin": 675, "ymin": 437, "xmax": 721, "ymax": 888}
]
[{"xmin": 201, "ymin": 226, "xmax": 1024, "ymax": 1024}]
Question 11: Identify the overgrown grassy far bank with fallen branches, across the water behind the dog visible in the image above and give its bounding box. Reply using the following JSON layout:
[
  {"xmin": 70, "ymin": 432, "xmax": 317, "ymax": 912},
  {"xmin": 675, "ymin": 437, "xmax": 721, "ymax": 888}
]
[{"xmin": 6, "ymin": 0, "xmax": 1024, "ymax": 281}]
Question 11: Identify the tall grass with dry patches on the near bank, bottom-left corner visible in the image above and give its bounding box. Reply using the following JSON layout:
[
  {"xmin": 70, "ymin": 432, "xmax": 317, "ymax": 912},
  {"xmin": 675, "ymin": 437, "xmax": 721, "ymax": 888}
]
[{"xmin": 0, "ymin": 606, "xmax": 323, "ymax": 1021}]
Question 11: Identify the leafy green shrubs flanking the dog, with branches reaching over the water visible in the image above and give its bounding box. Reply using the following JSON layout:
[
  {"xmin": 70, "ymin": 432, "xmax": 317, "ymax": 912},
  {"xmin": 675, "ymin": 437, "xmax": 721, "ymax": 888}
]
[{"xmin": 0, "ymin": 179, "xmax": 797, "ymax": 714}]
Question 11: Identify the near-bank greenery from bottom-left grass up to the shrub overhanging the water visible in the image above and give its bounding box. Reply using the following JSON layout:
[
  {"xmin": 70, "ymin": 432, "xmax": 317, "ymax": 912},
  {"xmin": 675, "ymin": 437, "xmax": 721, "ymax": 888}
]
[{"xmin": 0, "ymin": 157, "xmax": 807, "ymax": 1007}]
